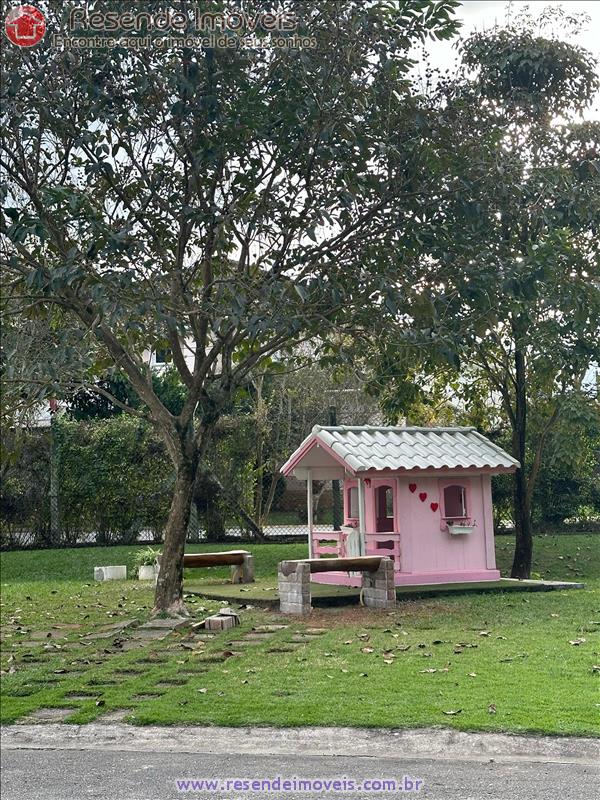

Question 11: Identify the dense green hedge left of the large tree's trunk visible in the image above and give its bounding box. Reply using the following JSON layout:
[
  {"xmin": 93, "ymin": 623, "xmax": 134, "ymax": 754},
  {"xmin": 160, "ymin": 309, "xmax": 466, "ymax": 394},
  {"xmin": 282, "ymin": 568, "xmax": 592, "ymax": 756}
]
[{"xmin": 0, "ymin": 415, "xmax": 173, "ymax": 547}]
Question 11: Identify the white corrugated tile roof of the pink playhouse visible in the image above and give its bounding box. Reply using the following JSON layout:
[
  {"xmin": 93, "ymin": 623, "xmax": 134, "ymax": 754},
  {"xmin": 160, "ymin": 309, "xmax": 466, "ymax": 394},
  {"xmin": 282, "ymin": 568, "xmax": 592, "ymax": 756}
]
[{"xmin": 281, "ymin": 425, "xmax": 519, "ymax": 475}]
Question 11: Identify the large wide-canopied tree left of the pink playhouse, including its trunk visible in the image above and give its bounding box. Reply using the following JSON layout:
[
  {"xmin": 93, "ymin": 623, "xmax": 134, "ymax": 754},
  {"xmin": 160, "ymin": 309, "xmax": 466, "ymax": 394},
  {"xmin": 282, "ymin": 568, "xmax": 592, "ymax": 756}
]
[{"xmin": 1, "ymin": 0, "xmax": 458, "ymax": 613}]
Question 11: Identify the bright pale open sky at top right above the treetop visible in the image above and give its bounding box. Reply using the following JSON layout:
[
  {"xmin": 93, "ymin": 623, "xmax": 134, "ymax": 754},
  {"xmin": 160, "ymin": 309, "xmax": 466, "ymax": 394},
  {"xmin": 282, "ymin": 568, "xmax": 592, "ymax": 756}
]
[{"xmin": 427, "ymin": 0, "xmax": 600, "ymax": 119}]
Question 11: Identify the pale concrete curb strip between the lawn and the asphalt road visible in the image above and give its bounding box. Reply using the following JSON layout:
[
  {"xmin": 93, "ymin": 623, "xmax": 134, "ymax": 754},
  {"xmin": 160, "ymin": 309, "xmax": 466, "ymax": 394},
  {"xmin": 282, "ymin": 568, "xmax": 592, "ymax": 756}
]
[{"xmin": 0, "ymin": 723, "xmax": 600, "ymax": 767}]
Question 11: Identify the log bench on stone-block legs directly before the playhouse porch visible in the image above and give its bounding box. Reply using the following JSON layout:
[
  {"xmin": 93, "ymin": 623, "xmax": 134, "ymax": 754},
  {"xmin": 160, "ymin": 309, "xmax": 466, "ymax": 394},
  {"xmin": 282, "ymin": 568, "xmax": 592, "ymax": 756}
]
[{"xmin": 278, "ymin": 556, "xmax": 396, "ymax": 614}]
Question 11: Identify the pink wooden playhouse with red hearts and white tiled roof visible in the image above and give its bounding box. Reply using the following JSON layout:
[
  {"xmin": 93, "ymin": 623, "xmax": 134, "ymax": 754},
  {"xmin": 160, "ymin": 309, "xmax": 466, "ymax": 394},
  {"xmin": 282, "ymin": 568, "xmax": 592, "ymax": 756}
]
[{"xmin": 281, "ymin": 426, "xmax": 519, "ymax": 585}]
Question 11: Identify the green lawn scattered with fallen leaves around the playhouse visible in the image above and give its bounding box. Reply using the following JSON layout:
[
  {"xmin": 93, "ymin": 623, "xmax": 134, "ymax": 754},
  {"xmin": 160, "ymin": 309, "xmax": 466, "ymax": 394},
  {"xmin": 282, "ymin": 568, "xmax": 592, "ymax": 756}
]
[{"xmin": 1, "ymin": 534, "xmax": 600, "ymax": 736}]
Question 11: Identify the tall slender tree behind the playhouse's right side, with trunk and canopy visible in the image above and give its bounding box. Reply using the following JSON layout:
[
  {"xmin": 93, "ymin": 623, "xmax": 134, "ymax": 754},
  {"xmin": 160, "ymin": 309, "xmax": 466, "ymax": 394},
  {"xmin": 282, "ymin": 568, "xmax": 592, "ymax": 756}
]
[{"xmin": 364, "ymin": 7, "xmax": 600, "ymax": 578}]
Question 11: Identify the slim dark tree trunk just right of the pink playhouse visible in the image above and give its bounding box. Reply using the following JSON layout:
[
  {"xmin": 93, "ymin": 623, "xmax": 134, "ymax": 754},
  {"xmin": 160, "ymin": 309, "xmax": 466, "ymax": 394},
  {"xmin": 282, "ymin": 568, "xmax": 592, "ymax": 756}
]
[{"xmin": 510, "ymin": 349, "xmax": 533, "ymax": 578}]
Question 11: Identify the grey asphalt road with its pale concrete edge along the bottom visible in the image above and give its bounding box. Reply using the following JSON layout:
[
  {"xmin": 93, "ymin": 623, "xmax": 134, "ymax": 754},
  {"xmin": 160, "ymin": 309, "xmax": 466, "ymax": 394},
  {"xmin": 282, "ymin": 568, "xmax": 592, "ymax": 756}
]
[{"xmin": 2, "ymin": 726, "xmax": 600, "ymax": 800}]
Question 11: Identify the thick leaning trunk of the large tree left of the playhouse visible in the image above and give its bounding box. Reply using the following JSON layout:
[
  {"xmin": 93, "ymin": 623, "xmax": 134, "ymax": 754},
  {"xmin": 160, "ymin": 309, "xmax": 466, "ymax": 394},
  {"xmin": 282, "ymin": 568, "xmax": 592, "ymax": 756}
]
[{"xmin": 153, "ymin": 459, "xmax": 196, "ymax": 615}]
